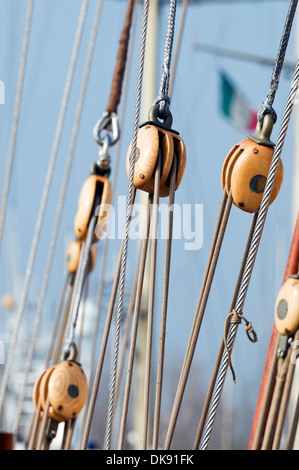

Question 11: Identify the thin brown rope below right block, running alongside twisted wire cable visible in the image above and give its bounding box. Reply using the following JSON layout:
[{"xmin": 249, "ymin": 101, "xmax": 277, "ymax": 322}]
[{"xmin": 193, "ymin": 214, "xmax": 257, "ymax": 450}]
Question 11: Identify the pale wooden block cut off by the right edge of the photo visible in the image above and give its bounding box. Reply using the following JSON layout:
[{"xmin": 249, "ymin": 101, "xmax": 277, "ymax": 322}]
[{"xmin": 275, "ymin": 276, "xmax": 299, "ymax": 336}]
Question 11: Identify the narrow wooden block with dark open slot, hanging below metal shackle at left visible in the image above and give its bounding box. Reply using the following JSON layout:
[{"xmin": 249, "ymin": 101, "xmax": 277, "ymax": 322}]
[{"xmin": 74, "ymin": 174, "xmax": 112, "ymax": 243}]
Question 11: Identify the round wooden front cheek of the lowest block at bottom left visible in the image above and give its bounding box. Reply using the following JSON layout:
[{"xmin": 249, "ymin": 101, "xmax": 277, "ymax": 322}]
[{"xmin": 48, "ymin": 361, "xmax": 88, "ymax": 420}]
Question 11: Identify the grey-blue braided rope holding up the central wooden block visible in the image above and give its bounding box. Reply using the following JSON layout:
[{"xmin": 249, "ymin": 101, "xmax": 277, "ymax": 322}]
[{"xmin": 155, "ymin": 0, "xmax": 177, "ymax": 119}]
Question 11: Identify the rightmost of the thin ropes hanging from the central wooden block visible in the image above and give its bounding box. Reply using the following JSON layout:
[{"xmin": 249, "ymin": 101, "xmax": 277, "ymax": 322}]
[{"xmin": 152, "ymin": 154, "xmax": 177, "ymax": 450}]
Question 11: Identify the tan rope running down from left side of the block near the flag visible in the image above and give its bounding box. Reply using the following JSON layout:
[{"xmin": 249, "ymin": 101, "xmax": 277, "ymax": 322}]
[{"xmin": 164, "ymin": 190, "xmax": 232, "ymax": 450}]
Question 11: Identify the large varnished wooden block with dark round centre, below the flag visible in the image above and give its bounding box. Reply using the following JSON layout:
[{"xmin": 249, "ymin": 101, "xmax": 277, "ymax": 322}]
[{"xmin": 221, "ymin": 139, "xmax": 283, "ymax": 213}]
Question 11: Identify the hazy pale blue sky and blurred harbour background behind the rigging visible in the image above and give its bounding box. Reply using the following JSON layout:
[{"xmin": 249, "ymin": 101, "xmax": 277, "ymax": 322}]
[{"xmin": 0, "ymin": 0, "xmax": 299, "ymax": 449}]
